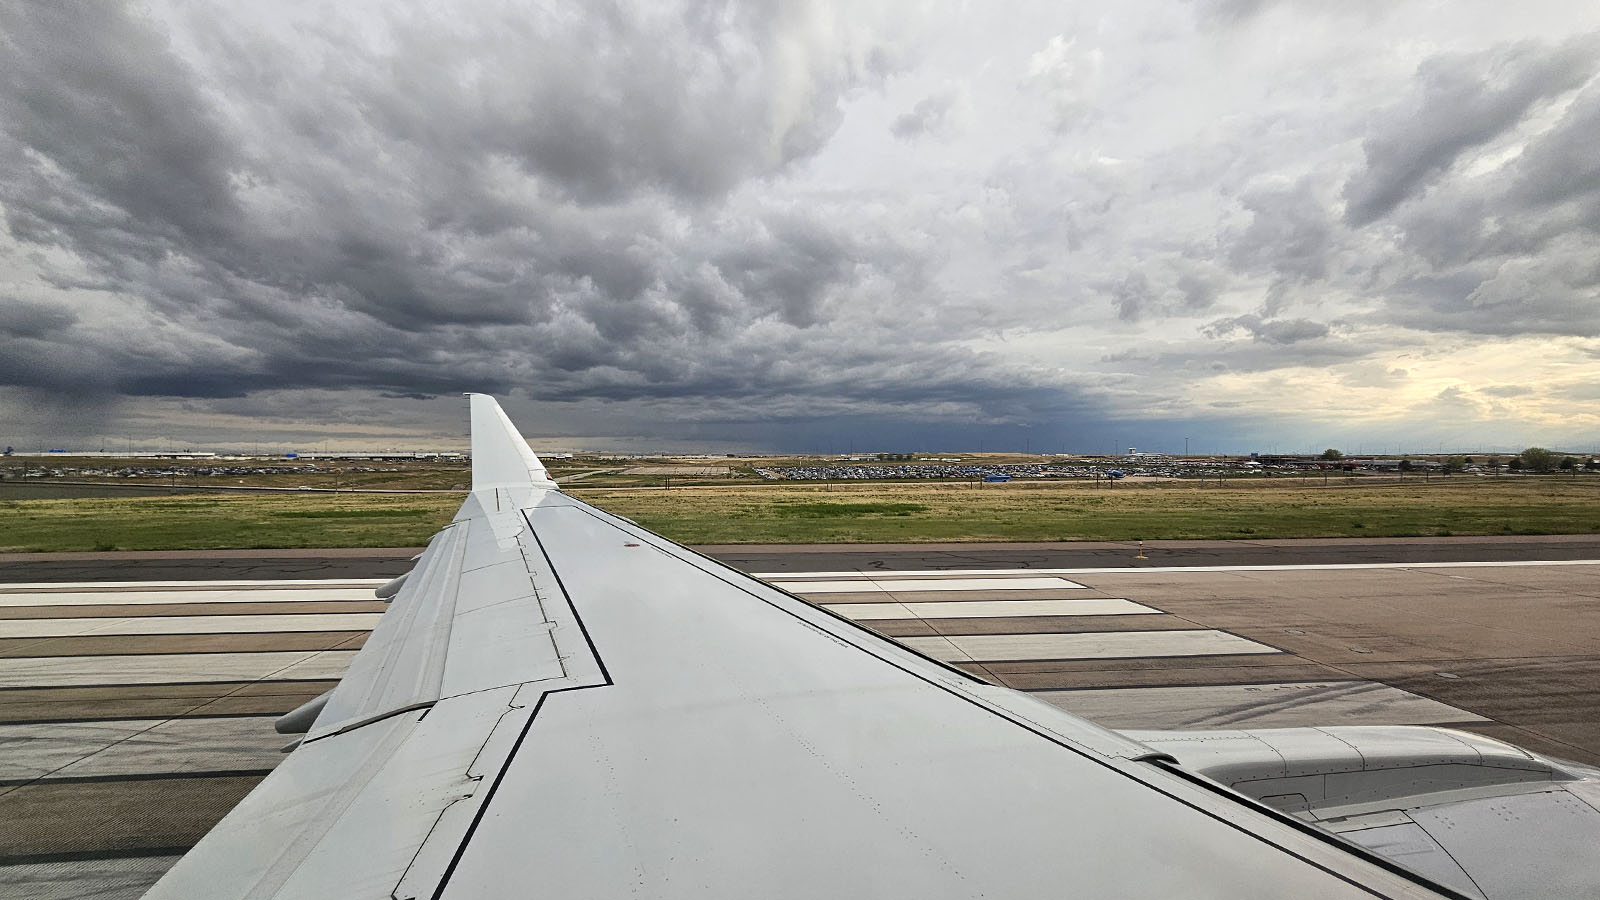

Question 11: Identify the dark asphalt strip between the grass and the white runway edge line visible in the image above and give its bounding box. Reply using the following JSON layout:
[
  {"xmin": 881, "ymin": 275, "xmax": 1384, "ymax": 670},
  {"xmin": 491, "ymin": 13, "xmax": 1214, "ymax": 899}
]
[{"xmin": 0, "ymin": 535, "xmax": 1600, "ymax": 583}]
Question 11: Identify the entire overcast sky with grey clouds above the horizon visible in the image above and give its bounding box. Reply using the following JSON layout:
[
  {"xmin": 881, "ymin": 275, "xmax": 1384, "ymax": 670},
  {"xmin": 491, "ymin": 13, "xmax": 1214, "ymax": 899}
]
[{"xmin": 0, "ymin": 0, "xmax": 1600, "ymax": 452}]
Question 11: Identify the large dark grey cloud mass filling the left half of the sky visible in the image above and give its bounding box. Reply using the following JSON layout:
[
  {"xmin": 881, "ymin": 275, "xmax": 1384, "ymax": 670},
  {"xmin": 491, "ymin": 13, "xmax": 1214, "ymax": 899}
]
[{"xmin": 0, "ymin": 5, "xmax": 915, "ymax": 406}]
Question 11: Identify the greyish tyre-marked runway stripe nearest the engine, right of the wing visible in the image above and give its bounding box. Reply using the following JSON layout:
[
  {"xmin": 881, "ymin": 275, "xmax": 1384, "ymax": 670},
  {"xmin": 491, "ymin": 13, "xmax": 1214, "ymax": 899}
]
[{"xmin": 1034, "ymin": 681, "xmax": 1488, "ymax": 729}]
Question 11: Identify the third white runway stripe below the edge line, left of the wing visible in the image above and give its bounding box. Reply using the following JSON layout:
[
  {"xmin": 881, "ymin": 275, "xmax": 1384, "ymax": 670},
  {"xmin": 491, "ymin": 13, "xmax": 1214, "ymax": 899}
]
[{"xmin": 0, "ymin": 650, "xmax": 355, "ymax": 687}]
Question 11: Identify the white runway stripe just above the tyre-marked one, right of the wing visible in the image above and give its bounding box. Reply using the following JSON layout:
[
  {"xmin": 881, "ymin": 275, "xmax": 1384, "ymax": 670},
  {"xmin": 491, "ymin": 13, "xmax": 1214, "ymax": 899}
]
[{"xmin": 899, "ymin": 629, "xmax": 1282, "ymax": 663}]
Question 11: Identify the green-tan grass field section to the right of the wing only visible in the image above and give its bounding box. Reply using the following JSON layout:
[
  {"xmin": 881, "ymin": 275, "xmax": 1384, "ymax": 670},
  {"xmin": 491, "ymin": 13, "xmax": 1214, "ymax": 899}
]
[{"xmin": 582, "ymin": 479, "xmax": 1600, "ymax": 543}]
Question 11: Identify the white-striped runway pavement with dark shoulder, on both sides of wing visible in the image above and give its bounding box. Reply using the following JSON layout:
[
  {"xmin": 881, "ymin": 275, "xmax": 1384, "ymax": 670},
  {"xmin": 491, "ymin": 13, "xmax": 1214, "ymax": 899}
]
[{"xmin": 0, "ymin": 538, "xmax": 1600, "ymax": 898}]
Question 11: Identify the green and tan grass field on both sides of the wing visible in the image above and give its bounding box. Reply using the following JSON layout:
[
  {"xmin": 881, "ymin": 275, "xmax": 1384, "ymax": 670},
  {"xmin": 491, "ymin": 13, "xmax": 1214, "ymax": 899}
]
[{"xmin": 0, "ymin": 476, "xmax": 1600, "ymax": 552}]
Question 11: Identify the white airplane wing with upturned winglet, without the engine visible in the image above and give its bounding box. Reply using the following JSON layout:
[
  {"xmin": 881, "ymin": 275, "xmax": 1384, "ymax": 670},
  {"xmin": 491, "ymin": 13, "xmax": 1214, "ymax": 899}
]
[{"xmin": 147, "ymin": 394, "xmax": 1450, "ymax": 900}]
